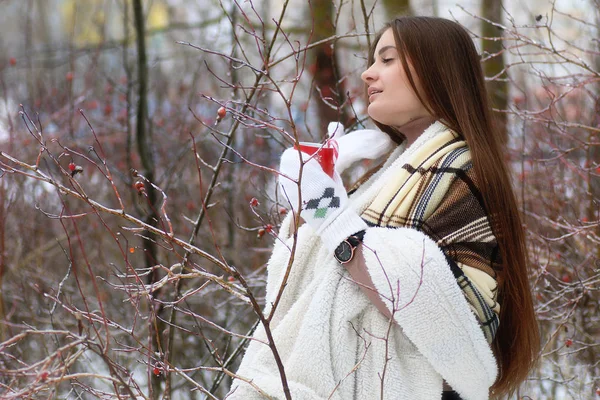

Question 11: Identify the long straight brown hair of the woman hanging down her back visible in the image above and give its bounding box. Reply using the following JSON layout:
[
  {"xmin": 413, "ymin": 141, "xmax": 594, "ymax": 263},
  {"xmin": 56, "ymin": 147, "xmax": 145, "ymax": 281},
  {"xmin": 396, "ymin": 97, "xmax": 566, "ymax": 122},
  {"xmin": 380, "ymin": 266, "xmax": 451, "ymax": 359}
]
[{"xmin": 368, "ymin": 16, "xmax": 540, "ymax": 396}]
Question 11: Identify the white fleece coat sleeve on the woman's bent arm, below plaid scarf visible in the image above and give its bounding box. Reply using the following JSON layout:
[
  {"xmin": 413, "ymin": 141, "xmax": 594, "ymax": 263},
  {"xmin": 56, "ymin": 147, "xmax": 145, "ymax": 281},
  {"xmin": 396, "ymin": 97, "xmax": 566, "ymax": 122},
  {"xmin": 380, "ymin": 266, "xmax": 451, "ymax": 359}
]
[{"xmin": 363, "ymin": 227, "xmax": 497, "ymax": 400}]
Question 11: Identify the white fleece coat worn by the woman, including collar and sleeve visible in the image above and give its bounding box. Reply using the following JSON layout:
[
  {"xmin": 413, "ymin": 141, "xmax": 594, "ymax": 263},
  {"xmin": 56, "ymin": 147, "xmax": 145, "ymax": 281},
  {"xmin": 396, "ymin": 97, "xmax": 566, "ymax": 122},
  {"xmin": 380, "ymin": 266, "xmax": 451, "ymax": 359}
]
[{"xmin": 227, "ymin": 127, "xmax": 497, "ymax": 400}]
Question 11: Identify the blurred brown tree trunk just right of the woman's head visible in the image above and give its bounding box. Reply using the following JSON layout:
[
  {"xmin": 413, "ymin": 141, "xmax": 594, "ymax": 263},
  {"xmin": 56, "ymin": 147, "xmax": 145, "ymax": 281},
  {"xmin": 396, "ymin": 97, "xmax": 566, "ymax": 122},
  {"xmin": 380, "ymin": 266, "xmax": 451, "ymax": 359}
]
[{"xmin": 481, "ymin": 0, "xmax": 508, "ymax": 143}]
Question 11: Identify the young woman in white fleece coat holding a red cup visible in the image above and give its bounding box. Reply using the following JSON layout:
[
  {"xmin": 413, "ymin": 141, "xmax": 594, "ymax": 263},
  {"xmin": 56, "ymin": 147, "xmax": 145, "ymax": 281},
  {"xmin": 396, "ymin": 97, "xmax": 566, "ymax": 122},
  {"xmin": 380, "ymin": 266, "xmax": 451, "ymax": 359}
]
[{"xmin": 228, "ymin": 17, "xmax": 539, "ymax": 400}]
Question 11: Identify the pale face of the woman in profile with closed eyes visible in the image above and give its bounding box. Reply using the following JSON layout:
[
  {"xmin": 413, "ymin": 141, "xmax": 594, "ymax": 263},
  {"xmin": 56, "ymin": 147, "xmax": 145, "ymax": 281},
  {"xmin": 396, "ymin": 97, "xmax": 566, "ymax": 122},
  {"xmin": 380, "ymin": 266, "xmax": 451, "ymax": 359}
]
[{"xmin": 361, "ymin": 29, "xmax": 430, "ymax": 128}]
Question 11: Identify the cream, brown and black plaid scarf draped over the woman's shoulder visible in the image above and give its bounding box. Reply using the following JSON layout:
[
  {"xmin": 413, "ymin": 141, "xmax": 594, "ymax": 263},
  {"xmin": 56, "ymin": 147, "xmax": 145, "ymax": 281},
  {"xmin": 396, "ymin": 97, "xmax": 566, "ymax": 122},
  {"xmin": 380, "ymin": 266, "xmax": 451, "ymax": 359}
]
[{"xmin": 361, "ymin": 130, "xmax": 501, "ymax": 343}]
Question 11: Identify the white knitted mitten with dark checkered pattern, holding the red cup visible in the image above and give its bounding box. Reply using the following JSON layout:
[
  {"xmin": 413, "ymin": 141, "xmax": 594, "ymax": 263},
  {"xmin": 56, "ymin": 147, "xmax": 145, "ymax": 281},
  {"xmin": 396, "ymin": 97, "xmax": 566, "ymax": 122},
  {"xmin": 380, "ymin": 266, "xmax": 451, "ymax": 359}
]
[{"xmin": 279, "ymin": 148, "xmax": 367, "ymax": 251}]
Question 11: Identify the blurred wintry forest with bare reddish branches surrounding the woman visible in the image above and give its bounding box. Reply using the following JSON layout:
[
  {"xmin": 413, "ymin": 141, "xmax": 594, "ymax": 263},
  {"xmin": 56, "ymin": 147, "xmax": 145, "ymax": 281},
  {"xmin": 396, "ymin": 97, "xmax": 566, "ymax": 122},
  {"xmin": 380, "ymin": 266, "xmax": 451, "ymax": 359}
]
[{"xmin": 0, "ymin": 0, "xmax": 600, "ymax": 399}]
